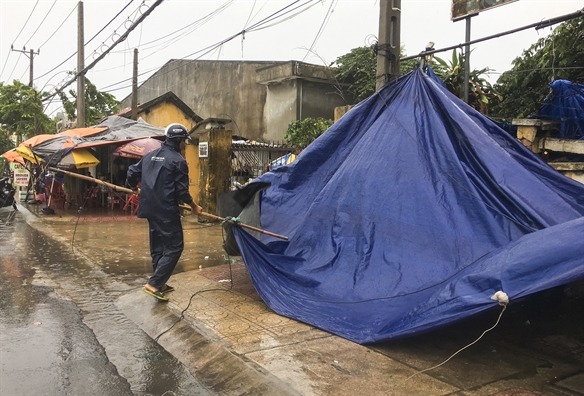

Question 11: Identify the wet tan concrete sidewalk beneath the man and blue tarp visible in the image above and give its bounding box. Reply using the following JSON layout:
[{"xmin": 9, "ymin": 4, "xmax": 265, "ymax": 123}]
[{"xmin": 14, "ymin": 203, "xmax": 584, "ymax": 396}]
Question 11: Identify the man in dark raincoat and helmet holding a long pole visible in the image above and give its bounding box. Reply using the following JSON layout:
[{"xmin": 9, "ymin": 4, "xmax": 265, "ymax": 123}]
[{"xmin": 127, "ymin": 124, "xmax": 203, "ymax": 301}]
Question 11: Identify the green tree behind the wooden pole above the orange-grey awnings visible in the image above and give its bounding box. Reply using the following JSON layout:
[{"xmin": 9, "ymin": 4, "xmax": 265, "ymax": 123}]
[{"xmin": 59, "ymin": 72, "xmax": 121, "ymax": 125}]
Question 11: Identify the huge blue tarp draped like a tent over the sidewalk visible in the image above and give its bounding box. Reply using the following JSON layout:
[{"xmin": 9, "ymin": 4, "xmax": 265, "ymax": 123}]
[{"xmin": 234, "ymin": 70, "xmax": 584, "ymax": 343}]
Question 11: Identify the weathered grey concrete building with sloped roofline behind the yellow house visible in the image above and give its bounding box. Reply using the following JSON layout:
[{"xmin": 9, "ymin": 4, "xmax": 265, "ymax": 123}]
[{"xmin": 122, "ymin": 60, "xmax": 346, "ymax": 142}]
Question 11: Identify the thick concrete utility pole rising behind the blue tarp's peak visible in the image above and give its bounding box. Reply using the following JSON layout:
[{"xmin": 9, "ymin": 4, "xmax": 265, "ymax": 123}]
[{"xmin": 375, "ymin": 0, "xmax": 401, "ymax": 90}]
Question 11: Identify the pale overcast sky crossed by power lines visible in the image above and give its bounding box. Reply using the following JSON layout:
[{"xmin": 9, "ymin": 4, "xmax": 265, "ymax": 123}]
[{"xmin": 0, "ymin": 0, "xmax": 584, "ymax": 115}]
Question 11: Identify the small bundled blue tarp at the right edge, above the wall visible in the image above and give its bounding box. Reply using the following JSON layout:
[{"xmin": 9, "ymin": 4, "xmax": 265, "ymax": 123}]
[{"xmin": 530, "ymin": 80, "xmax": 584, "ymax": 139}]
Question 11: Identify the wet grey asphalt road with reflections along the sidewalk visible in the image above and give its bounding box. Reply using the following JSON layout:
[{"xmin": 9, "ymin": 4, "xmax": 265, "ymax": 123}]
[{"xmin": 0, "ymin": 208, "xmax": 211, "ymax": 396}]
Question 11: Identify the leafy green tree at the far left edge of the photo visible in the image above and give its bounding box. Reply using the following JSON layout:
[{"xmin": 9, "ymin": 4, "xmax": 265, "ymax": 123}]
[{"xmin": 0, "ymin": 80, "xmax": 54, "ymax": 141}]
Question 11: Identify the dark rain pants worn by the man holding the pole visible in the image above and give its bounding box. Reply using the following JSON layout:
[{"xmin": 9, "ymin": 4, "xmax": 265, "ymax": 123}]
[{"xmin": 148, "ymin": 219, "xmax": 184, "ymax": 289}]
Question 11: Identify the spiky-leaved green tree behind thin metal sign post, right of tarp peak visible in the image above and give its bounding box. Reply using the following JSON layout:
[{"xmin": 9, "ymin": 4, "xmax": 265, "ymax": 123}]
[{"xmin": 430, "ymin": 50, "xmax": 501, "ymax": 114}]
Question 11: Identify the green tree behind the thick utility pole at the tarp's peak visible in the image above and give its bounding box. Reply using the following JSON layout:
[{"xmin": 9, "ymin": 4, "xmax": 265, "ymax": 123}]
[{"xmin": 331, "ymin": 46, "xmax": 416, "ymax": 102}]
